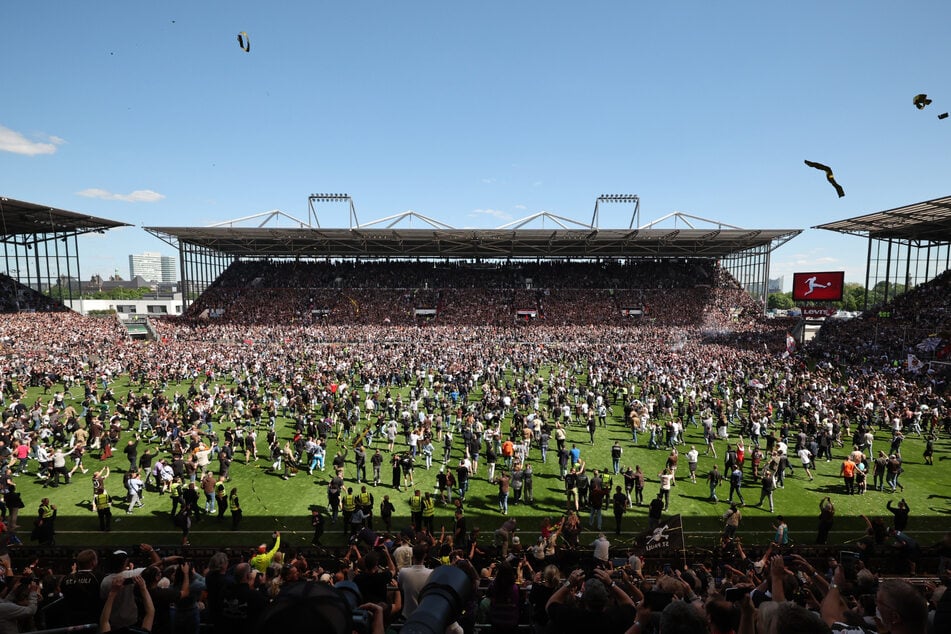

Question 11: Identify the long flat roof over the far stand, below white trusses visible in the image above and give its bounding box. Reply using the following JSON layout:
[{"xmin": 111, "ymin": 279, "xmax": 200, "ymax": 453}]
[{"xmin": 146, "ymin": 226, "xmax": 801, "ymax": 259}]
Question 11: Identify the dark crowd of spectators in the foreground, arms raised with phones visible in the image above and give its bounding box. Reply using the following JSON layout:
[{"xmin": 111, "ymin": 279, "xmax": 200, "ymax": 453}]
[{"xmin": 0, "ymin": 526, "xmax": 951, "ymax": 634}]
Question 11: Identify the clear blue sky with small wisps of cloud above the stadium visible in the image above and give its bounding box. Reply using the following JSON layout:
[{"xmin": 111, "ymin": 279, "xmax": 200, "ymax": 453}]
[{"xmin": 0, "ymin": 0, "xmax": 951, "ymax": 288}]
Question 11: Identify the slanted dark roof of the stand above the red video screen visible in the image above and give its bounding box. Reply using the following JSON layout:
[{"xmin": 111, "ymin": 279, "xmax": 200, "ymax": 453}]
[{"xmin": 814, "ymin": 196, "xmax": 951, "ymax": 242}]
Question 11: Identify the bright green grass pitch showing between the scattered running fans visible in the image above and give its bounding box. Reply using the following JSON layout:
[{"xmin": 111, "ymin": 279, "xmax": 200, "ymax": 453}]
[{"xmin": 16, "ymin": 370, "xmax": 951, "ymax": 547}]
